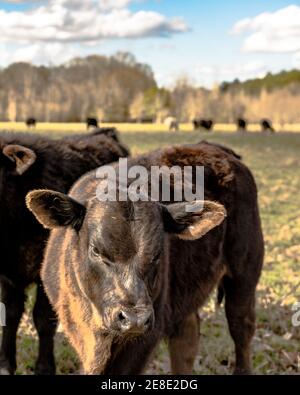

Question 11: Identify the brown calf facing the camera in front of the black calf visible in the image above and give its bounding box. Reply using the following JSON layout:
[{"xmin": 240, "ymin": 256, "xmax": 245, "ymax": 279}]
[{"xmin": 26, "ymin": 142, "xmax": 264, "ymax": 374}]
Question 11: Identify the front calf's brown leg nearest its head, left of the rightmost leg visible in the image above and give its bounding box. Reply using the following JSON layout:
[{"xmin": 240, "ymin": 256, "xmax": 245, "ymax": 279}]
[{"xmin": 169, "ymin": 313, "xmax": 200, "ymax": 374}]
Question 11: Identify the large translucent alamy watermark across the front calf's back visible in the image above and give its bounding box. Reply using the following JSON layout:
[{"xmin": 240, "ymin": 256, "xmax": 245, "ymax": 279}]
[{"xmin": 96, "ymin": 158, "xmax": 204, "ymax": 212}]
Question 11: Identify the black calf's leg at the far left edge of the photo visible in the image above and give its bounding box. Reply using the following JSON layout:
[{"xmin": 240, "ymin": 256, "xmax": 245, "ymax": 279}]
[{"xmin": 0, "ymin": 280, "xmax": 25, "ymax": 375}]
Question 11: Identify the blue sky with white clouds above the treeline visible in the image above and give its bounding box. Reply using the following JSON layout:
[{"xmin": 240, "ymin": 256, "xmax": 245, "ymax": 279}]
[{"xmin": 0, "ymin": 0, "xmax": 300, "ymax": 88}]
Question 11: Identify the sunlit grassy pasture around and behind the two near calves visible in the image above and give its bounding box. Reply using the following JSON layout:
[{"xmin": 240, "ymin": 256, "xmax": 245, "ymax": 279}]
[{"xmin": 0, "ymin": 124, "xmax": 300, "ymax": 374}]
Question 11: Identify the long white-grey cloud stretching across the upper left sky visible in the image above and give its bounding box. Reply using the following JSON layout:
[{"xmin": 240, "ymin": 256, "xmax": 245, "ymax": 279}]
[{"xmin": 0, "ymin": 0, "xmax": 187, "ymax": 44}]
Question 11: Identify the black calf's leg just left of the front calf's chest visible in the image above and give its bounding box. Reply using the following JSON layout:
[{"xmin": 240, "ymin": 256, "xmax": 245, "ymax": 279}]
[{"xmin": 33, "ymin": 283, "xmax": 57, "ymax": 375}]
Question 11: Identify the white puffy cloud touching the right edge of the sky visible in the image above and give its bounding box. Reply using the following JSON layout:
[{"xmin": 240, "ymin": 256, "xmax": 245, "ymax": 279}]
[{"xmin": 231, "ymin": 5, "xmax": 300, "ymax": 53}]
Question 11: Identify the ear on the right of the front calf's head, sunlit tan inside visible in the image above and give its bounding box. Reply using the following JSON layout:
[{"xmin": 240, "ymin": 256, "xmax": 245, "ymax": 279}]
[{"xmin": 162, "ymin": 200, "xmax": 226, "ymax": 240}]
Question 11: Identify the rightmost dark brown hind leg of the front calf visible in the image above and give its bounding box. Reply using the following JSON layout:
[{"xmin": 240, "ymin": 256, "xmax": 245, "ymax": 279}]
[{"xmin": 224, "ymin": 278, "xmax": 255, "ymax": 374}]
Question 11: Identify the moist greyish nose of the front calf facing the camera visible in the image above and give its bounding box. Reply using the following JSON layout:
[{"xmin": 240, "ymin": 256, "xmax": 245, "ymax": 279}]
[{"xmin": 118, "ymin": 309, "xmax": 153, "ymax": 333}]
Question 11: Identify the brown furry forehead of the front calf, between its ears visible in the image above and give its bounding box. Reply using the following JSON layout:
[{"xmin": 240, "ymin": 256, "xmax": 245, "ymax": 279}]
[{"xmin": 87, "ymin": 199, "xmax": 163, "ymax": 261}]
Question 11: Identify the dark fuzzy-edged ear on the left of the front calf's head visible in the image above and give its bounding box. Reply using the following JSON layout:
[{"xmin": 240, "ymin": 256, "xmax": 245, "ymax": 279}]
[{"xmin": 26, "ymin": 189, "xmax": 86, "ymax": 231}]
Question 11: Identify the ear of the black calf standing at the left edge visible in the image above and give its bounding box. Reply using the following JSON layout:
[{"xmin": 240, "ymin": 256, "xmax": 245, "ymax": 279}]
[{"xmin": 3, "ymin": 144, "xmax": 36, "ymax": 176}]
